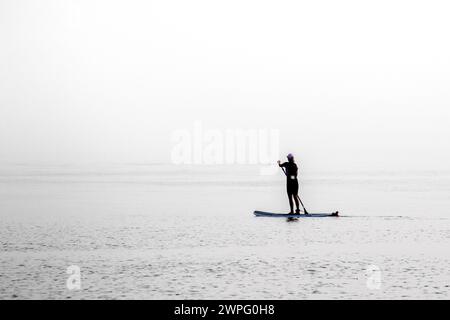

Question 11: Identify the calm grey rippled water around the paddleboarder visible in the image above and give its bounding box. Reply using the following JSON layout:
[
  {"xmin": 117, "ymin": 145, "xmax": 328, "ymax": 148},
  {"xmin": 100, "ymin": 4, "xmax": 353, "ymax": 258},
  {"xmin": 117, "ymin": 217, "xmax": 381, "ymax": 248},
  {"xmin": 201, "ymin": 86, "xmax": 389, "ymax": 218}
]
[{"xmin": 0, "ymin": 165, "xmax": 450, "ymax": 299}]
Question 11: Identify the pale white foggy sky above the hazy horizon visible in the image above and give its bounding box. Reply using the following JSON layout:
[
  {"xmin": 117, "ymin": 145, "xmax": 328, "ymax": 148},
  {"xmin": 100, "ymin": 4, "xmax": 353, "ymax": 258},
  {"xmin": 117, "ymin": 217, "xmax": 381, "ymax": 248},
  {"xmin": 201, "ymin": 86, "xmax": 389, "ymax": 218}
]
[{"xmin": 0, "ymin": 0, "xmax": 450, "ymax": 170}]
